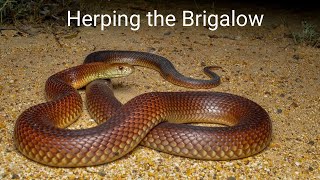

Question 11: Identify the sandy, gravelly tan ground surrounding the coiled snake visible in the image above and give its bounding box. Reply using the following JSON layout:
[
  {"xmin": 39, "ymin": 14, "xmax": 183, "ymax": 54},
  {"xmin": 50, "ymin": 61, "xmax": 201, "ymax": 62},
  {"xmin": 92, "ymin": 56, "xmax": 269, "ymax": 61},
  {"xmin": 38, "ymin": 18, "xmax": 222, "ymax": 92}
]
[{"xmin": 0, "ymin": 2, "xmax": 320, "ymax": 180}]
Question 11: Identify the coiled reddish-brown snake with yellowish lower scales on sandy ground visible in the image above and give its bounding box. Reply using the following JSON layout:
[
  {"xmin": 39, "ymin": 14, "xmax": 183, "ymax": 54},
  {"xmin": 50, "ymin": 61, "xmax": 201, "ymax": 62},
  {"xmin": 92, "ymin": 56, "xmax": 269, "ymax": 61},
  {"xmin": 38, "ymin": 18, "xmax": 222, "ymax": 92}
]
[{"xmin": 13, "ymin": 51, "xmax": 272, "ymax": 167}]
